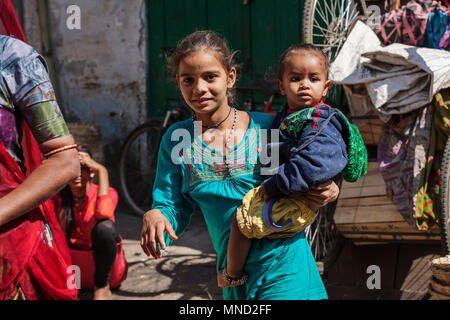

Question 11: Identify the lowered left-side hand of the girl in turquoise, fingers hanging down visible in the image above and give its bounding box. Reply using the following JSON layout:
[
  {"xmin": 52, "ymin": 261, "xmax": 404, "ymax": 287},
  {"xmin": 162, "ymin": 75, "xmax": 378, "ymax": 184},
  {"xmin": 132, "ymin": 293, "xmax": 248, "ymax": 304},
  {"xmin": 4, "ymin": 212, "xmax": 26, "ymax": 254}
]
[{"xmin": 141, "ymin": 209, "xmax": 178, "ymax": 259}]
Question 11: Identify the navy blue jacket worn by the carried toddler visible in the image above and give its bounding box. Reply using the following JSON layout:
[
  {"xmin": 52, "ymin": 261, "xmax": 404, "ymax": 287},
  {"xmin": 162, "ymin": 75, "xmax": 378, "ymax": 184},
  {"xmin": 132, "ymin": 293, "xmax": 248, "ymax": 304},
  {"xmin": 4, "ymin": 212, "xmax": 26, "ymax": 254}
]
[{"xmin": 264, "ymin": 103, "xmax": 348, "ymax": 198}]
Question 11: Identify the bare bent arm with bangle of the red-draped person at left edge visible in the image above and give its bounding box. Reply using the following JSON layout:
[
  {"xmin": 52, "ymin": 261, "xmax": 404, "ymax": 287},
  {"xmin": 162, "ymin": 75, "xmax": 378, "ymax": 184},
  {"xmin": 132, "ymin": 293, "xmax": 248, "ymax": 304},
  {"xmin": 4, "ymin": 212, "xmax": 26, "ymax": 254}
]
[{"xmin": 0, "ymin": 136, "xmax": 80, "ymax": 226}]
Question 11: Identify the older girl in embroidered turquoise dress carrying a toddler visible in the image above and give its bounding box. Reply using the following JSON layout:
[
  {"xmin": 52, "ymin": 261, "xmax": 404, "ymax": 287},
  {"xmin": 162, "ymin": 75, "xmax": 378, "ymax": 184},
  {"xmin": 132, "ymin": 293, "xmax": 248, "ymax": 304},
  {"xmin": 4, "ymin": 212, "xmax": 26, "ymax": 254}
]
[{"xmin": 141, "ymin": 31, "xmax": 336, "ymax": 299}]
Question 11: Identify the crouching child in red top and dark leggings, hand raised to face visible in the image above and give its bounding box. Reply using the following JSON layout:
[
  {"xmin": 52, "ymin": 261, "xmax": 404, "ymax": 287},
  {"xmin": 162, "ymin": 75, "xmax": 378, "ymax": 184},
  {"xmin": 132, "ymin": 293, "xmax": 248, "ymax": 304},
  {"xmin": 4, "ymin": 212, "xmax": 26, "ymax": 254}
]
[{"xmin": 59, "ymin": 145, "xmax": 120, "ymax": 300}]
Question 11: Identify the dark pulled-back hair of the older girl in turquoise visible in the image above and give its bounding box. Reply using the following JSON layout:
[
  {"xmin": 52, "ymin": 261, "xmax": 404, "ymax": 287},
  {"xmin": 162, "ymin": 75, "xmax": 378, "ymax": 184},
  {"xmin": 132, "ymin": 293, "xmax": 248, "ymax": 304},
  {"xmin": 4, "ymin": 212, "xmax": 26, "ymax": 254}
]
[{"xmin": 167, "ymin": 30, "xmax": 238, "ymax": 106}]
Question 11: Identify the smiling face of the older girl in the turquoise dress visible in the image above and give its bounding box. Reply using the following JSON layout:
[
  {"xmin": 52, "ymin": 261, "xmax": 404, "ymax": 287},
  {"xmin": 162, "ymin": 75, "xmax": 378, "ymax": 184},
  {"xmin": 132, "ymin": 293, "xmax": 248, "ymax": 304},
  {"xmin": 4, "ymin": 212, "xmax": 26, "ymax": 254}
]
[{"xmin": 177, "ymin": 49, "xmax": 236, "ymax": 115}]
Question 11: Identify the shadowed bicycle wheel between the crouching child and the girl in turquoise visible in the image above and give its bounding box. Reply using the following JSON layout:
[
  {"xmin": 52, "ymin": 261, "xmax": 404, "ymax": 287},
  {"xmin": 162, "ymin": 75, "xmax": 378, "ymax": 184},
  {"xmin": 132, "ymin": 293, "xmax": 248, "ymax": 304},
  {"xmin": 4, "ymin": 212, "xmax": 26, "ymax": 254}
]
[{"xmin": 119, "ymin": 120, "xmax": 163, "ymax": 216}]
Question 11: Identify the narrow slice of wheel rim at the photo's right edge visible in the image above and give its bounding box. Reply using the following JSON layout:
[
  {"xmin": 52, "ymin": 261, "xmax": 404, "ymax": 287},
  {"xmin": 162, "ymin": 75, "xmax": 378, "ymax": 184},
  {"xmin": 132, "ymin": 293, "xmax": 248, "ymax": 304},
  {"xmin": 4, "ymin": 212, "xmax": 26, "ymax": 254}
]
[{"xmin": 439, "ymin": 139, "xmax": 450, "ymax": 256}]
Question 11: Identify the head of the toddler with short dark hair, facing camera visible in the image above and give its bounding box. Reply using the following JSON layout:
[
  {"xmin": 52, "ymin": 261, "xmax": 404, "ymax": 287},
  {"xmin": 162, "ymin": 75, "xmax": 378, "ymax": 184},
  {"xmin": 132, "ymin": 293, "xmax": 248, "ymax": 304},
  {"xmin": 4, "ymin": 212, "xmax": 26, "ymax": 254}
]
[{"xmin": 278, "ymin": 50, "xmax": 331, "ymax": 110}]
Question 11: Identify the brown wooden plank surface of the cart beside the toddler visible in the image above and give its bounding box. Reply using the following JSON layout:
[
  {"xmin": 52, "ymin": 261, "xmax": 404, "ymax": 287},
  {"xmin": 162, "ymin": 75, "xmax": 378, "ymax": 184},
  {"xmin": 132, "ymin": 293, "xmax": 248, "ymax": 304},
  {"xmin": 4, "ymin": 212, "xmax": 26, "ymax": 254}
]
[{"xmin": 334, "ymin": 162, "xmax": 440, "ymax": 242}]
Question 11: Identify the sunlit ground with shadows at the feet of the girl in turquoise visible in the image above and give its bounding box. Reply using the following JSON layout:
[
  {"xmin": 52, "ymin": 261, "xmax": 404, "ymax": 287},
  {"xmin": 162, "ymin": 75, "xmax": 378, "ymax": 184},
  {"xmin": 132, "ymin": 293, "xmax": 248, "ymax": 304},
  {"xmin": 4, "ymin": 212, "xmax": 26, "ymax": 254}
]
[{"xmin": 79, "ymin": 205, "xmax": 223, "ymax": 300}]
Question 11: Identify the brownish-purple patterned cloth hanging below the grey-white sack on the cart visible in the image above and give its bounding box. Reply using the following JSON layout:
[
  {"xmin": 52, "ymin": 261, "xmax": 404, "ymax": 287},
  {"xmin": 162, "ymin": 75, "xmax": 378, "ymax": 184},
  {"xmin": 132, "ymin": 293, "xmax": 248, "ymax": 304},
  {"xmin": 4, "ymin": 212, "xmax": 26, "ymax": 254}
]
[{"xmin": 378, "ymin": 105, "xmax": 432, "ymax": 228}]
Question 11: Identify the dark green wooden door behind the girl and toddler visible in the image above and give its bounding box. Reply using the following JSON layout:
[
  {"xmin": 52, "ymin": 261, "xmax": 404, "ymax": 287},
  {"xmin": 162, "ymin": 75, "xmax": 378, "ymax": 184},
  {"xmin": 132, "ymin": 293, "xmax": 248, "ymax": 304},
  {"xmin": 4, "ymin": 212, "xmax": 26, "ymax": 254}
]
[{"xmin": 147, "ymin": 0, "xmax": 304, "ymax": 117}]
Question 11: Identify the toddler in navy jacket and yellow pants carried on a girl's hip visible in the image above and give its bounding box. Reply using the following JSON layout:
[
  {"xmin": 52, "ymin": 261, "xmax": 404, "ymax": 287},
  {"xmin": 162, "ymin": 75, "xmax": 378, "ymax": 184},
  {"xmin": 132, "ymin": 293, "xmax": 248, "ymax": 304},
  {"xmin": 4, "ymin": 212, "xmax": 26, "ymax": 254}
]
[{"xmin": 218, "ymin": 45, "xmax": 367, "ymax": 287}]
